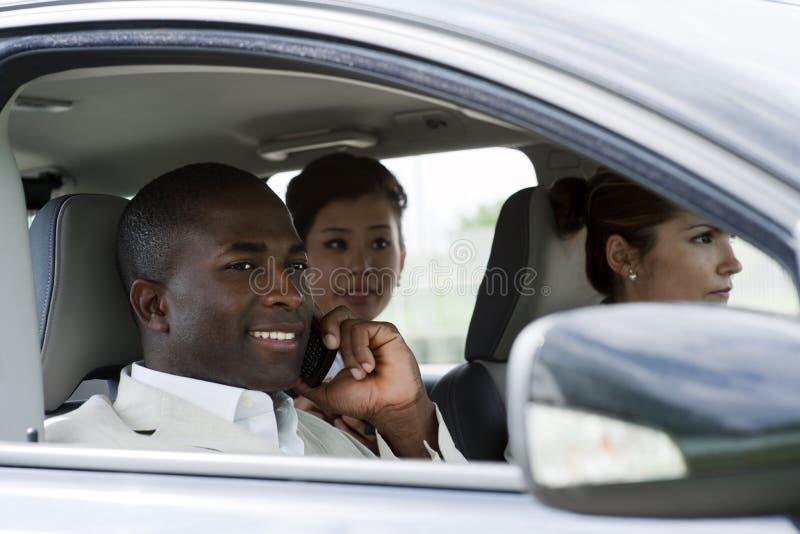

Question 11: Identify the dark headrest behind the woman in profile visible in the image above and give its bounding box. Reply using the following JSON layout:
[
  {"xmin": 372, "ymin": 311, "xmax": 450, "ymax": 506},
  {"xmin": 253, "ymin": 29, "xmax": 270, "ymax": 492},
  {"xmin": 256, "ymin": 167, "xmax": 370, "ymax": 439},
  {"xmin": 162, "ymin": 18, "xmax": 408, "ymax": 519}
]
[{"xmin": 465, "ymin": 186, "xmax": 602, "ymax": 361}]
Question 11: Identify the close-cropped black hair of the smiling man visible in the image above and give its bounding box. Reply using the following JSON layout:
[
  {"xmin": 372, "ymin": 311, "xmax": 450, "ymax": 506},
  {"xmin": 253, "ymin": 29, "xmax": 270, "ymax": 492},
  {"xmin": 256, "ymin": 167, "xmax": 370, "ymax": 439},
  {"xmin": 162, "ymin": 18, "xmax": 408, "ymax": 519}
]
[{"xmin": 117, "ymin": 163, "xmax": 259, "ymax": 291}]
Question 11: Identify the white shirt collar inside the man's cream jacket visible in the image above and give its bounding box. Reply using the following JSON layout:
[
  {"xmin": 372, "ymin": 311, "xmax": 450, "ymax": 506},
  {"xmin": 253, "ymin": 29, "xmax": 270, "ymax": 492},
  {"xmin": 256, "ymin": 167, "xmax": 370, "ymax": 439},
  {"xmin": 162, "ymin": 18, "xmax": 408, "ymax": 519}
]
[{"xmin": 131, "ymin": 362, "xmax": 304, "ymax": 456}]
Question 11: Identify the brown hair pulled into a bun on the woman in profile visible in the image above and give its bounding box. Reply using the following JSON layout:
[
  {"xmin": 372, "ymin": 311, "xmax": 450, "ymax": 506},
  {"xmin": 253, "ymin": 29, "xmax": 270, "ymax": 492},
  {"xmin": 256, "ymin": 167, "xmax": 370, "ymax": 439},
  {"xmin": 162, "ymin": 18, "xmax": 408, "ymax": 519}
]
[{"xmin": 550, "ymin": 168, "xmax": 682, "ymax": 300}]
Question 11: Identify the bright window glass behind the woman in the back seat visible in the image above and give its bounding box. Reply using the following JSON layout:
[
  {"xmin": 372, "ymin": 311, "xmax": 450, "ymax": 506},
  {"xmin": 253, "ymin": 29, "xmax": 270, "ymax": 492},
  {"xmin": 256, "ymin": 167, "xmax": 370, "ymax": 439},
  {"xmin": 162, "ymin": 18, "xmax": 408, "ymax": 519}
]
[{"xmin": 269, "ymin": 148, "xmax": 536, "ymax": 363}]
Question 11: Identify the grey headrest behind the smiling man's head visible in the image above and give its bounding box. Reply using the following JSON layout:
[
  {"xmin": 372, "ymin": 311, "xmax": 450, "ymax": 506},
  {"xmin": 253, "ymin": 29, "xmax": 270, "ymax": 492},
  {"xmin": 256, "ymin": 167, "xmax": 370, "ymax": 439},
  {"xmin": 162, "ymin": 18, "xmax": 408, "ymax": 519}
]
[{"xmin": 30, "ymin": 194, "xmax": 142, "ymax": 411}]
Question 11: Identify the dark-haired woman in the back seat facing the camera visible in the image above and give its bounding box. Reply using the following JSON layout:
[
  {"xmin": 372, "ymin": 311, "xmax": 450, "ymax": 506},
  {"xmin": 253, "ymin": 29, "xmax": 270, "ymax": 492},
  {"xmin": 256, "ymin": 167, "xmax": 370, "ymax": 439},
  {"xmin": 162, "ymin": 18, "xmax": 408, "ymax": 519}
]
[{"xmin": 286, "ymin": 153, "xmax": 407, "ymax": 450}]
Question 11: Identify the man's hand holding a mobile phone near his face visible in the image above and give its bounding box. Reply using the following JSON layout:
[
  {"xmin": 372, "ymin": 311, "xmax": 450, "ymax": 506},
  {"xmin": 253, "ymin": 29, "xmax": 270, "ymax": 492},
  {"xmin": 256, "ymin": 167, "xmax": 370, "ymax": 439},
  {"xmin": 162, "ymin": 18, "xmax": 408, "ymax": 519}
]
[{"xmin": 295, "ymin": 306, "xmax": 438, "ymax": 458}]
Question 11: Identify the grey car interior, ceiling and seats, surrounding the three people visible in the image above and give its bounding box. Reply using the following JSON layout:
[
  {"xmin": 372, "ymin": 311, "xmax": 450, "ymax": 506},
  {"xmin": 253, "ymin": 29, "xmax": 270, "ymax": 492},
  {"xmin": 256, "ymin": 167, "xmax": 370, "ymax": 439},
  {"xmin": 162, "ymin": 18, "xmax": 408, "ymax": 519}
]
[{"xmin": 15, "ymin": 60, "xmax": 620, "ymax": 461}]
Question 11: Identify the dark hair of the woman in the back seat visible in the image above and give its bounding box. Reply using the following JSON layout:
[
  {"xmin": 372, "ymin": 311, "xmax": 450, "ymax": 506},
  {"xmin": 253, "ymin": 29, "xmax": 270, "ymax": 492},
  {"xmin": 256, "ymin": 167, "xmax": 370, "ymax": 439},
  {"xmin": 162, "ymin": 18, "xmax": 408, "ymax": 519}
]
[{"xmin": 286, "ymin": 153, "xmax": 408, "ymax": 248}]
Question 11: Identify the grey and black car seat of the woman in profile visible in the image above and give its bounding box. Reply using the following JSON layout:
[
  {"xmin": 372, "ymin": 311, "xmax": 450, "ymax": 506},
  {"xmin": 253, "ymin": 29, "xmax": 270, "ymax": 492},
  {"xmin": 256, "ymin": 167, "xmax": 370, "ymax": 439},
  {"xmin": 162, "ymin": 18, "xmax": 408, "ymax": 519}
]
[{"xmin": 432, "ymin": 186, "xmax": 601, "ymax": 461}]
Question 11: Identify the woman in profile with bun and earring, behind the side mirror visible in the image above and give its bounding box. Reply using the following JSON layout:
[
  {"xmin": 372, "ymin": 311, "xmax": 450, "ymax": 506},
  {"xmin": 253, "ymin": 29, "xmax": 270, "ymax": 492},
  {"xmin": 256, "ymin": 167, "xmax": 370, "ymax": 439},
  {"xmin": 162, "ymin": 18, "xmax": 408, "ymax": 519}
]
[{"xmin": 550, "ymin": 169, "xmax": 742, "ymax": 303}]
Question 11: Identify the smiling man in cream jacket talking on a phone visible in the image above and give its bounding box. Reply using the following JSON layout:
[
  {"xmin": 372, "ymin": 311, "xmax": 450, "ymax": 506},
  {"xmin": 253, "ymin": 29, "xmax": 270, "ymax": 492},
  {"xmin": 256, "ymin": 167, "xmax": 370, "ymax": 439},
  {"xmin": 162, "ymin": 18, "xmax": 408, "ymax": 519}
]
[{"xmin": 45, "ymin": 163, "xmax": 463, "ymax": 461}]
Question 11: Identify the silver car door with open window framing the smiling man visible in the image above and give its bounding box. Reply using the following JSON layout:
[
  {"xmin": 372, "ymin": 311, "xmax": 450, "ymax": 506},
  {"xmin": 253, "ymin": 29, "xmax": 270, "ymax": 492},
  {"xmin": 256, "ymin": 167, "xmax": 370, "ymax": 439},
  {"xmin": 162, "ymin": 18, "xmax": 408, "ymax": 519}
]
[{"xmin": 0, "ymin": 2, "xmax": 800, "ymax": 532}]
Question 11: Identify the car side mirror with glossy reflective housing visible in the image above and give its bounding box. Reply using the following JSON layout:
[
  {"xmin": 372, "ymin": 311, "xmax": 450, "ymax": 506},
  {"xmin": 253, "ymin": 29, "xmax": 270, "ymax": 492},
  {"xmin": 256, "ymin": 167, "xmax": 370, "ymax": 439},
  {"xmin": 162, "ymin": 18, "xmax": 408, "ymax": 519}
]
[{"xmin": 508, "ymin": 303, "xmax": 800, "ymax": 517}]
